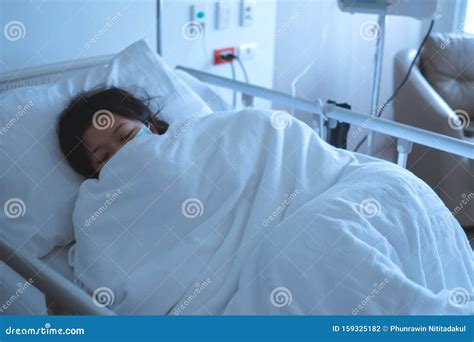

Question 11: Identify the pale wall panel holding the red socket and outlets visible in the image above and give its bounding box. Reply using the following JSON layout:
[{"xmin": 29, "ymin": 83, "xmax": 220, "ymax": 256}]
[{"xmin": 160, "ymin": 0, "xmax": 278, "ymax": 107}]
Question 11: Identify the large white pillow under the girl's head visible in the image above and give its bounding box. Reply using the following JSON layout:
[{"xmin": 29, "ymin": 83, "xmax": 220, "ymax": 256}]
[{"xmin": 0, "ymin": 41, "xmax": 211, "ymax": 257}]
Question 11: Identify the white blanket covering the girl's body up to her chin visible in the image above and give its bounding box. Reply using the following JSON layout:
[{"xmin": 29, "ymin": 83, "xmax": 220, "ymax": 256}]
[{"xmin": 74, "ymin": 110, "xmax": 474, "ymax": 315}]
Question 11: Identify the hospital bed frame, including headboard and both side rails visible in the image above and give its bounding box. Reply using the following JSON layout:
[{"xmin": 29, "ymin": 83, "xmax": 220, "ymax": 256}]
[{"xmin": 0, "ymin": 56, "xmax": 474, "ymax": 315}]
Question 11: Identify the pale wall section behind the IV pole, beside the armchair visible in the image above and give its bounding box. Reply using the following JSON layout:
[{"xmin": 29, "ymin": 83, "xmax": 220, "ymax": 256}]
[{"xmin": 274, "ymin": 1, "xmax": 421, "ymax": 158}]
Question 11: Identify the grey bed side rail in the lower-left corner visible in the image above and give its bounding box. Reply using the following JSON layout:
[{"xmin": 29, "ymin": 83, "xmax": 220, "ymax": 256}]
[{"xmin": 0, "ymin": 239, "xmax": 115, "ymax": 316}]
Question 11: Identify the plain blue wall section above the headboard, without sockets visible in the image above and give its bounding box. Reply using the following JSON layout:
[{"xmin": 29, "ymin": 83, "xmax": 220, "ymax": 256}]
[{"xmin": 0, "ymin": 0, "xmax": 158, "ymax": 72}]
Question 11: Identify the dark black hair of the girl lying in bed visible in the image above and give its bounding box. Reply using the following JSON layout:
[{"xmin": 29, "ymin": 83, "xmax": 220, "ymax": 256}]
[{"xmin": 57, "ymin": 87, "xmax": 168, "ymax": 178}]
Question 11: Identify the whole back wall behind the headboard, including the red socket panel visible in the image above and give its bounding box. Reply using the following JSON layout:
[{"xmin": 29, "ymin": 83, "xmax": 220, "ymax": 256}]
[{"xmin": 0, "ymin": 0, "xmax": 276, "ymax": 107}]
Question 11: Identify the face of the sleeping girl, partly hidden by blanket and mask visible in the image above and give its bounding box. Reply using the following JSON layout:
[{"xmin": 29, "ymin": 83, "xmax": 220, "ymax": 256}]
[{"xmin": 84, "ymin": 115, "xmax": 156, "ymax": 174}]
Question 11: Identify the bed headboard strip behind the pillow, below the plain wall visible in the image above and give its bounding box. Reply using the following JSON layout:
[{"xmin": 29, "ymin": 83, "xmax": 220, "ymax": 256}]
[{"xmin": 0, "ymin": 55, "xmax": 113, "ymax": 93}]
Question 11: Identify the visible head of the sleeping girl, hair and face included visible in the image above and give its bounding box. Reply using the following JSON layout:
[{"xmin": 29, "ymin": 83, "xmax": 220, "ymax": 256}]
[{"xmin": 58, "ymin": 87, "xmax": 168, "ymax": 178}]
